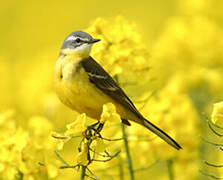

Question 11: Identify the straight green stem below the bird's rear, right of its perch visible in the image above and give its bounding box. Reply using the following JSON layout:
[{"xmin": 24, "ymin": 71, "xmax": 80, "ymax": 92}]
[{"xmin": 121, "ymin": 123, "xmax": 135, "ymax": 180}]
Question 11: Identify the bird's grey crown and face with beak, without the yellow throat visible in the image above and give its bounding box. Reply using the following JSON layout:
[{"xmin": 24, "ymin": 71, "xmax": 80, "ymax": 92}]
[{"xmin": 61, "ymin": 31, "xmax": 100, "ymax": 51}]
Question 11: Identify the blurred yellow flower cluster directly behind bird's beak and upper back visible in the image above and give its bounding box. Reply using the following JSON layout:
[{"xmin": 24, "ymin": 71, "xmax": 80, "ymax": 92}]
[{"xmin": 87, "ymin": 16, "xmax": 148, "ymax": 80}]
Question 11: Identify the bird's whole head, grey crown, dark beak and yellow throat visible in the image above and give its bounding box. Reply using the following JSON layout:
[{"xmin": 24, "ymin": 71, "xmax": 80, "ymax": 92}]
[{"xmin": 61, "ymin": 31, "xmax": 100, "ymax": 56}]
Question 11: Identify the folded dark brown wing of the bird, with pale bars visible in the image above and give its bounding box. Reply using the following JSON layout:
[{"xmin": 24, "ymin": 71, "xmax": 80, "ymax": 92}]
[{"xmin": 81, "ymin": 57, "xmax": 143, "ymax": 119}]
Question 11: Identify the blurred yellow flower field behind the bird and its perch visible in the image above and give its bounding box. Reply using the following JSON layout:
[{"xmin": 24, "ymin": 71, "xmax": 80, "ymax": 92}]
[{"xmin": 0, "ymin": 0, "xmax": 223, "ymax": 180}]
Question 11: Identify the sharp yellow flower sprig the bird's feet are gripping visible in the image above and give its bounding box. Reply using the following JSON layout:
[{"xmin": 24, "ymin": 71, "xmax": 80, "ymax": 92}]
[{"xmin": 52, "ymin": 103, "xmax": 121, "ymax": 178}]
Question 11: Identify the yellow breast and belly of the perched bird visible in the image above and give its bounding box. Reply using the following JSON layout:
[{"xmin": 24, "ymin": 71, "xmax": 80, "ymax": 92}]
[{"xmin": 55, "ymin": 55, "xmax": 136, "ymax": 120}]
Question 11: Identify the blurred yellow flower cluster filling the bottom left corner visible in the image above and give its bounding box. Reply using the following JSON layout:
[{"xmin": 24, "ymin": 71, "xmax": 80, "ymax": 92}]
[{"xmin": 0, "ymin": 110, "xmax": 58, "ymax": 180}]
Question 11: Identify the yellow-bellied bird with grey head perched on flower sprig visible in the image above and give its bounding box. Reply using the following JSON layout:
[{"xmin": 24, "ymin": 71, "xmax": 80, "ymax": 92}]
[{"xmin": 54, "ymin": 31, "xmax": 182, "ymax": 150}]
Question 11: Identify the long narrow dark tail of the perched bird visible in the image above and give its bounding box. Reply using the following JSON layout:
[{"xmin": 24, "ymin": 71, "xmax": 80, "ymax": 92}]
[{"xmin": 142, "ymin": 119, "xmax": 182, "ymax": 150}]
